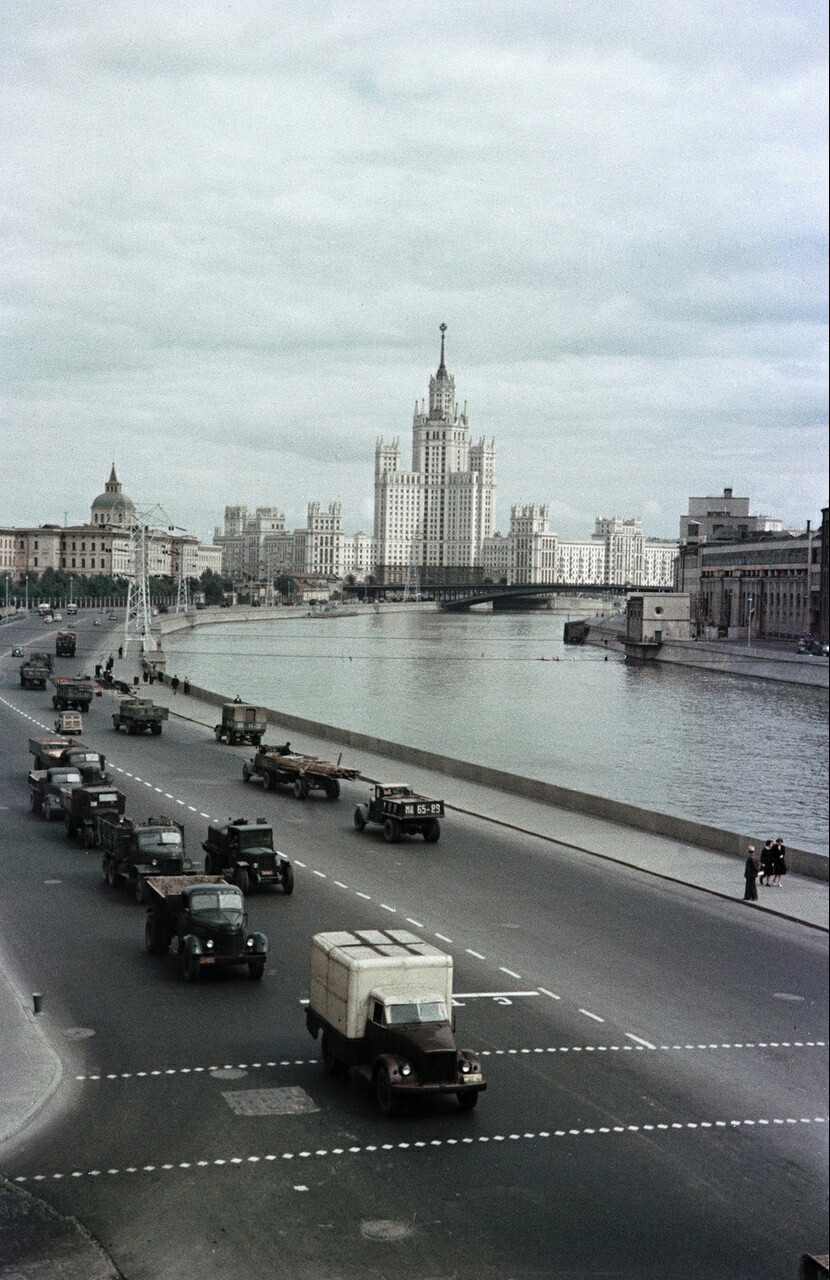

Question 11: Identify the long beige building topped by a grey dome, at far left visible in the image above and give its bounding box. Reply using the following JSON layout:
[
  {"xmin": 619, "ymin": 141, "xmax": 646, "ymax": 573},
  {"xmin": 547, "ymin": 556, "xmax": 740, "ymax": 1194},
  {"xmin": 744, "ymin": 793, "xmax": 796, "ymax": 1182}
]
[{"xmin": 0, "ymin": 463, "xmax": 222, "ymax": 580}]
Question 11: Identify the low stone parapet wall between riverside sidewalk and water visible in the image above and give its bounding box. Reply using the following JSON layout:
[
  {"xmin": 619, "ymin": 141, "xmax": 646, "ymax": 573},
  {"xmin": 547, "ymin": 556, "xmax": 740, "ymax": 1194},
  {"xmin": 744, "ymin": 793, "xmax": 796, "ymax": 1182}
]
[{"xmin": 155, "ymin": 665, "xmax": 830, "ymax": 881}]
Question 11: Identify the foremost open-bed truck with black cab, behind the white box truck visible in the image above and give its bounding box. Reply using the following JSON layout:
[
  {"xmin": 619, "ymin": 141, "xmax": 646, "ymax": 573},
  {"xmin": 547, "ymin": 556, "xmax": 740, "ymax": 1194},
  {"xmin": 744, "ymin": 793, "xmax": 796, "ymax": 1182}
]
[{"xmin": 145, "ymin": 876, "xmax": 268, "ymax": 982}]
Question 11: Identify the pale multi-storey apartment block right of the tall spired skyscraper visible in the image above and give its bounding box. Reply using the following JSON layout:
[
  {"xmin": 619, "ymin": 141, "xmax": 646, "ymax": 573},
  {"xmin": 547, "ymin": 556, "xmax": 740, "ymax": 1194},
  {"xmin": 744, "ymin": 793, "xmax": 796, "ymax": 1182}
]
[{"xmin": 482, "ymin": 503, "xmax": 678, "ymax": 588}]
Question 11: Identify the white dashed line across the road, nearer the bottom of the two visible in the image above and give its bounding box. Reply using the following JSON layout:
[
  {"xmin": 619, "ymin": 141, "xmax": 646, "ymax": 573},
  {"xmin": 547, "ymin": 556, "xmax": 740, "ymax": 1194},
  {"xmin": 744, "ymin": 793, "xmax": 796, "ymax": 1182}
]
[{"xmin": 13, "ymin": 1116, "xmax": 827, "ymax": 1185}]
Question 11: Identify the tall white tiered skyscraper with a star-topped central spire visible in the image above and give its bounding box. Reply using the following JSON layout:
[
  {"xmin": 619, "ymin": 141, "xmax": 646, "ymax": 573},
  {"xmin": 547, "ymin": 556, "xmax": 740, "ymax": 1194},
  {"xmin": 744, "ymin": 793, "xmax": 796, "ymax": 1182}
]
[{"xmin": 374, "ymin": 324, "xmax": 496, "ymax": 582}]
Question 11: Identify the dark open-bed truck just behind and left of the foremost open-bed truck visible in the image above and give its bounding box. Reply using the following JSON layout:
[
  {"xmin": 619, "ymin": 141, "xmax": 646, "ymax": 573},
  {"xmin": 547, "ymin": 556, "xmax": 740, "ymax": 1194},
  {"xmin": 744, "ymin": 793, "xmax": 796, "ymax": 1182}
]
[{"xmin": 92, "ymin": 814, "xmax": 199, "ymax": 905}]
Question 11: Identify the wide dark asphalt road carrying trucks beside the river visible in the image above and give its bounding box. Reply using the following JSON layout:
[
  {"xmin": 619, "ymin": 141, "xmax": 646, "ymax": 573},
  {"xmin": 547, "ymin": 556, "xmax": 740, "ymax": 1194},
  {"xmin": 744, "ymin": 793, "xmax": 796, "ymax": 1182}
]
[{"xmin": 0, "ymin": 614, "xmax": 829, "ymax": 1280}]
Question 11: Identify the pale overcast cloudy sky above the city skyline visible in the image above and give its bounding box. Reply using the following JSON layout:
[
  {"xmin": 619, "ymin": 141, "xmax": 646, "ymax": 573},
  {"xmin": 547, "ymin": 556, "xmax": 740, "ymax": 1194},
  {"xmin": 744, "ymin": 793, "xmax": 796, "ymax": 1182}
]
[{"xmin": 0, "ymin": 0, "xmax": 827, "ymax": 538}]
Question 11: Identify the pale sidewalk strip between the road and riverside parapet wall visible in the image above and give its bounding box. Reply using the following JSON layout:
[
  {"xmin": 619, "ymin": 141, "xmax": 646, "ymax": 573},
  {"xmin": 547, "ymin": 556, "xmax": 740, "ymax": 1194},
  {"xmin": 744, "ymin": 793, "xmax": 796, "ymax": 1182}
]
[{"xmin": 139, "ymin": 663, "xmax": 830, "ymax": 931}]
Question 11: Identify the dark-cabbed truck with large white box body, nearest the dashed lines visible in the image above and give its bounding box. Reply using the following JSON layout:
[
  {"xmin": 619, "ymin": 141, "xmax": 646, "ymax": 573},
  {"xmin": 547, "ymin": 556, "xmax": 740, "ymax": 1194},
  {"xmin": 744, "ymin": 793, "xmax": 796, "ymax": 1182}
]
[{"xmin": 306, "ymin": 929, "xmax": 487, "ymax": 1115}]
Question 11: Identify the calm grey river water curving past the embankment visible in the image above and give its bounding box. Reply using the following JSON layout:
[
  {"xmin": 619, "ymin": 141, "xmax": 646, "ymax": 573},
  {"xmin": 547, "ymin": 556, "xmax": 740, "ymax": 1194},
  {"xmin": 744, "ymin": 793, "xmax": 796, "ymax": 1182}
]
[{"xmin": 165, "ymin": 612, "xmax": 827, "ymax": 852}]
